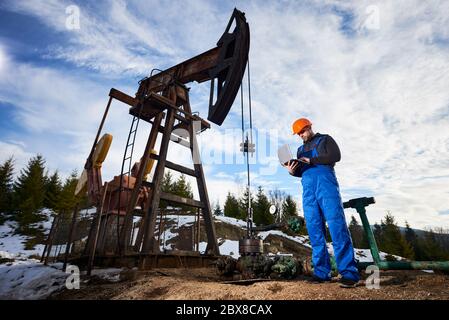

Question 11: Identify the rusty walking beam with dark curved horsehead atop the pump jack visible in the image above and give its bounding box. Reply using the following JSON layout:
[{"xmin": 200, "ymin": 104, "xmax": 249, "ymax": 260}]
[{"xmin": 136, "ymin": 9, "xmax": 250, "ymax": 125}]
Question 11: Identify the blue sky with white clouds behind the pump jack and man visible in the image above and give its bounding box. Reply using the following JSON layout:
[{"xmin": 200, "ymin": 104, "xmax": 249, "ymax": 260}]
[{"xmin": 0, "ymin": 0, "xmax": 449, "ymax": 228}]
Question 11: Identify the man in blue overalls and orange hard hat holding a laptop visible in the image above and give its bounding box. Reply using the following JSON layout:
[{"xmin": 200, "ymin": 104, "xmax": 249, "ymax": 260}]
[{"xmin": 286, "ymin": 118, "xmax": 360, "ymax": 288}]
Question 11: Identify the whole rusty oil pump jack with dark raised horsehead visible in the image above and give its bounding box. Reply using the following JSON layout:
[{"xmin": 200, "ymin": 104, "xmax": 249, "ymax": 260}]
[{"xmin": 66, "ymin": 9, "xmax": 250, "ymax": 271}]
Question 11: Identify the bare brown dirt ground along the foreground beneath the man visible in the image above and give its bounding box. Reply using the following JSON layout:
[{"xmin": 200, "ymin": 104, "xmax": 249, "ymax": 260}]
[{"xmin": 50, "ymin": 268, "xmax": 449, "ymax": 300}]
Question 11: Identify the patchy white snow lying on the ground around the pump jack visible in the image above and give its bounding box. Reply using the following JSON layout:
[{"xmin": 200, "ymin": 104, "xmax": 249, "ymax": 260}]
[{"xmin": 0, "ymin": 211, "xmax": 412, "ymax": 299}]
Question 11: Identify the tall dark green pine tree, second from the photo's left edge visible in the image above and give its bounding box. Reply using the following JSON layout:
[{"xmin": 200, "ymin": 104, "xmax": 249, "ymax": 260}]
[{"xmin": 14, "ymin": 155, "xmax": 46, "ymax": 229}]
